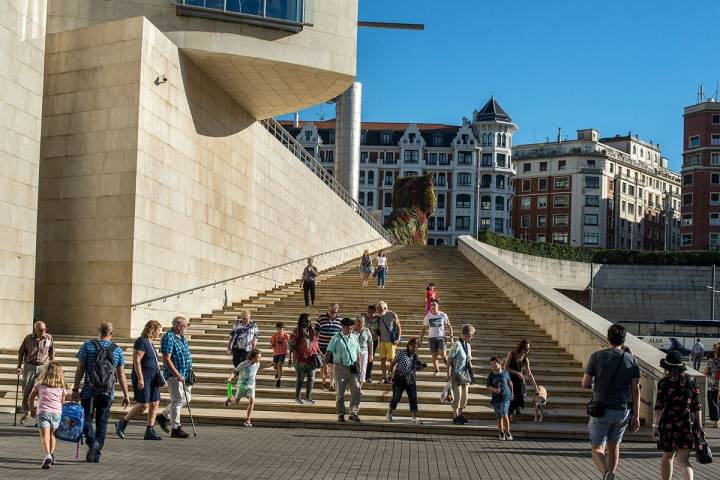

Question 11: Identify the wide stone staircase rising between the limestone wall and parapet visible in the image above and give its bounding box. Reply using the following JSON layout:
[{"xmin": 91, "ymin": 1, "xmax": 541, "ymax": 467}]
[{"xmin": 0, "ymin": 247, "xmax": 632, "ymax": 438}]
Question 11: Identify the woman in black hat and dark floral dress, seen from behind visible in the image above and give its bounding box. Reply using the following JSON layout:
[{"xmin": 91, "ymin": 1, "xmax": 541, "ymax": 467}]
[{"xmin": 653, "ymin": 351, "xmax": 702, "ymax": 480}]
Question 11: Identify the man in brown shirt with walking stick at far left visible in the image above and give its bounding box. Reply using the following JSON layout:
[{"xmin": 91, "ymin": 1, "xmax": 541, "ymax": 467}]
[{"xmin": 13, "ymin": 321, "xmax": 55, "ymax": 425}]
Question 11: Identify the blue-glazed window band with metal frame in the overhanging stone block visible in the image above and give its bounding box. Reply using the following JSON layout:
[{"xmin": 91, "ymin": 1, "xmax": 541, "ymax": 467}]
[{"xmin": 172, "ymin": 0, "xmax": 304, "ymax": 33}]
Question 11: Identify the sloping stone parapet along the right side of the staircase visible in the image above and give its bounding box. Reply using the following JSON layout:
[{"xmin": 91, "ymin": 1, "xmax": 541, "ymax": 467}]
[{"xmin": 458, "ymin": 235, "xmax": 705, "ymax": 425}]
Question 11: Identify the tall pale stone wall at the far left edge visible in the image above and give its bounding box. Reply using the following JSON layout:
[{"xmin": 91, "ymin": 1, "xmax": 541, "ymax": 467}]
[{"xmin": 0, "ymin": 0, "xmax": 47, "ymax": 348}]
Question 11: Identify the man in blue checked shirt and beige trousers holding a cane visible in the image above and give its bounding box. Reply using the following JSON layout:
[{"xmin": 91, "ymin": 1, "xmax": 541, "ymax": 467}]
[{"xmin": 157, "ymin": 317, "xmax": 192, "ymax": 438}]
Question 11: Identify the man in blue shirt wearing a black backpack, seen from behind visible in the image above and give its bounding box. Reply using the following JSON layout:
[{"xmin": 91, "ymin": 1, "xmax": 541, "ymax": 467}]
[{"xmin": 72, "ymin": 322, "xmax": 130, "ymax": 463}]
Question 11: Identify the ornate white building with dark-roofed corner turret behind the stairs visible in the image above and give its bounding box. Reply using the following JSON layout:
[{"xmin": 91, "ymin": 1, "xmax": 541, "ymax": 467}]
[{"xmin": 281, "ymin": 97, "xmax": 517, "ymax": 245}]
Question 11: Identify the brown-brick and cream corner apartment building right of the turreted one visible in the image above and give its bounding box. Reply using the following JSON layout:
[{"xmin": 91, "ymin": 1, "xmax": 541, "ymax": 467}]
[{"xmin": 512, "ymin": 129, "xmax": 680, "ymax": 250}]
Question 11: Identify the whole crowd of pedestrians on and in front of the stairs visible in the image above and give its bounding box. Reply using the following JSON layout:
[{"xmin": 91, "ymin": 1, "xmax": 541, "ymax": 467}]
[{"xmin": 9, "ymin": 251, "xmax": 720, "ymax": 480}]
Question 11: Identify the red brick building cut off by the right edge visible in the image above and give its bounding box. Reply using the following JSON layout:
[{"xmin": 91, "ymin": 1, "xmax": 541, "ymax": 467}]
[{"xmin": 681, "ymin": 99, "xmax": 720, "ymax": 250}]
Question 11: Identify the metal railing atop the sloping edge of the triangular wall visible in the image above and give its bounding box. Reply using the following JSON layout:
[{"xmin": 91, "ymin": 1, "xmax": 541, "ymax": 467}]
[{"xmin": 260, "ymin": 118, "xmax": 395, "ymax": 244}]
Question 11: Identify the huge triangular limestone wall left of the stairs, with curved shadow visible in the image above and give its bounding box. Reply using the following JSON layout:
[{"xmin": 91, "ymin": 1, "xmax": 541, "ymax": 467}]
[{"xmin": 38, "ymin": 18, "xmax": 387, "ymax": 335}]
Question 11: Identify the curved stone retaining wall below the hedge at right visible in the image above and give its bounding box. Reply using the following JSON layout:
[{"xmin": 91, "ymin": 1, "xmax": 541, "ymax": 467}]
[{"xmin": 476, "ymin": 245, "xmax": 720, "ymax": 322}]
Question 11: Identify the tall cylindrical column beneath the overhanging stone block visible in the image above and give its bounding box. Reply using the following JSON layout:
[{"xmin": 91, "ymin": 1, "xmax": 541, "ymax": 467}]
[{"xmin": 335, "ymin": 82, "xmax": 362, "ymax": 201}]
